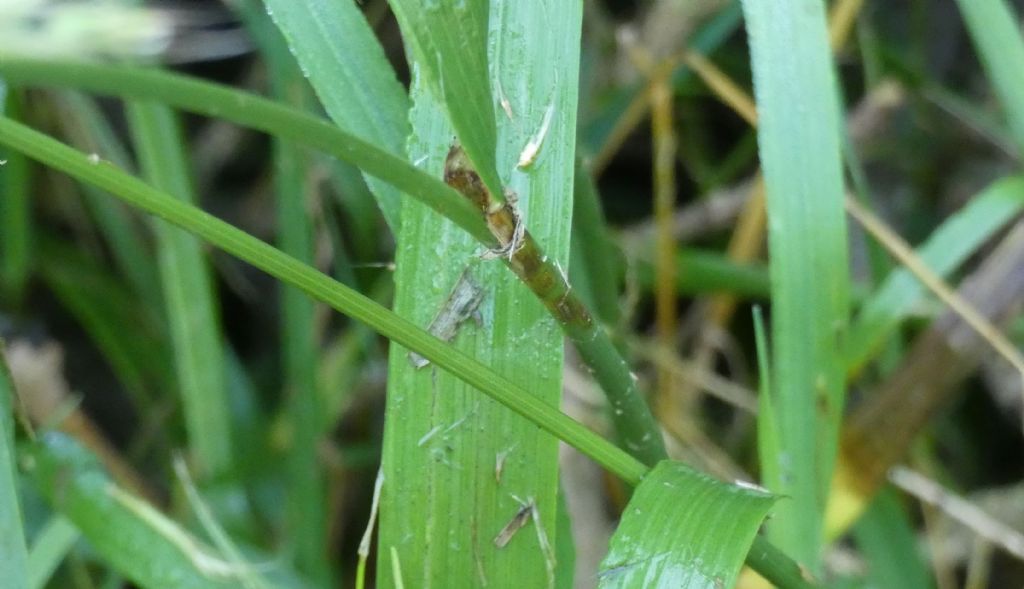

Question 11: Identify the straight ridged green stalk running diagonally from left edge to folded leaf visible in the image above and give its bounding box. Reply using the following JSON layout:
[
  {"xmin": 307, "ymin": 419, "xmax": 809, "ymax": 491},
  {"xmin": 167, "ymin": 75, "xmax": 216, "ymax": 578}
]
[{"xmin": 0, "ymin": 117, "xmax": 807, "ymax": 588}]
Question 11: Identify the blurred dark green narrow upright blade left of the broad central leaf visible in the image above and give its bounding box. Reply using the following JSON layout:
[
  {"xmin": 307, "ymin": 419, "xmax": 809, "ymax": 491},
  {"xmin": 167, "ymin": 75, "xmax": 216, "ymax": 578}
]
[{"xmin": 231, "ymin": 0, "xmax": 327, "ymax": 585}]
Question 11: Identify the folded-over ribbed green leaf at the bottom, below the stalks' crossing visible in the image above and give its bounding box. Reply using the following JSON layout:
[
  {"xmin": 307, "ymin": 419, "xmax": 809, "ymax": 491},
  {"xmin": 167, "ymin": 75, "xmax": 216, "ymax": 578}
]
[{"xmin": 598, "ymin": 460, "xmax": 775, "ymax": 589}]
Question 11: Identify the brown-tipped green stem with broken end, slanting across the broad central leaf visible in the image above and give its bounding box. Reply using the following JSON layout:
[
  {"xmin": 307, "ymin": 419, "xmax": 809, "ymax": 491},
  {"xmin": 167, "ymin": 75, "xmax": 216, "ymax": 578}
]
[{"xmin": 444, "ymin": 146, "xmax": 668, "ymax": 466}]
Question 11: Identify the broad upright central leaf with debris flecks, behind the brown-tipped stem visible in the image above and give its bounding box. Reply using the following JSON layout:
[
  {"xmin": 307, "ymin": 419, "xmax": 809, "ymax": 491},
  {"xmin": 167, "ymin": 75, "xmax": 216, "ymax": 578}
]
[{"xmin": 378, "ymin": 2, "xmax": 582, "ymax": 587}]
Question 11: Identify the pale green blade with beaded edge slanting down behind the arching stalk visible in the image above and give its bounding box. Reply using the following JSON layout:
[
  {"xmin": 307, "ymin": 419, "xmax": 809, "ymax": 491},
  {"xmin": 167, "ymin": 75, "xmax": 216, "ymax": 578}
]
[{"xmin": 264, "ymin": 0, "xmax": 409, "ymax": 233}]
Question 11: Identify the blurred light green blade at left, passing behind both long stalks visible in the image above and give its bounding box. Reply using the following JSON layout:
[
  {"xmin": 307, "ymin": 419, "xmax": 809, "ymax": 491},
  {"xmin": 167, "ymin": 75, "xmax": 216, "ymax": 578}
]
[{"xmin": 128, "ymin": 102, "xmax": 232, "ymax": 477}]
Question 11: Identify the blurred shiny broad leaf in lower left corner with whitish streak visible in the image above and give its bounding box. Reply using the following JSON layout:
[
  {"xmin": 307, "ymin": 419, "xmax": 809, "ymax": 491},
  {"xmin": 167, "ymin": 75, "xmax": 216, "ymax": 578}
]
[{"xmin": 24, "ymin": 432, "xmax": 296, "ymax": 589}]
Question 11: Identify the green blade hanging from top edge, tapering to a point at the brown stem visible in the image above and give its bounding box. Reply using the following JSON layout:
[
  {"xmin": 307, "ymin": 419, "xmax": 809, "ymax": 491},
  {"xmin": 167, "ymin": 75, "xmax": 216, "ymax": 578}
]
[{"xmin": 389, "ymin": 0, "xmax": 501, "ymax": 198}]
